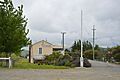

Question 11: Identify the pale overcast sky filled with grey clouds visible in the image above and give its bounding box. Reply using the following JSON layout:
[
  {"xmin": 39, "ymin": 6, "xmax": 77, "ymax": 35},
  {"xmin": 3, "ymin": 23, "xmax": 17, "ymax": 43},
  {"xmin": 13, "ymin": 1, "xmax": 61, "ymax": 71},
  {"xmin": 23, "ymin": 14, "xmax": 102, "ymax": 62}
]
[{"xmin": 13, "ymin": 0, "xmax": 120, "ymax": 47}]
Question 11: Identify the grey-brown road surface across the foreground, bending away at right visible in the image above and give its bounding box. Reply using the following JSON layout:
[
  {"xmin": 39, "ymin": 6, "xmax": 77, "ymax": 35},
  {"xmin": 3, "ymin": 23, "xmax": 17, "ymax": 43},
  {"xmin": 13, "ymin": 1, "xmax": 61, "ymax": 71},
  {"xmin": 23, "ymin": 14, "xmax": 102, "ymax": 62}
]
[{"xmin": 0, "ymin": 61, "xmax": 120, "ymax": 80}]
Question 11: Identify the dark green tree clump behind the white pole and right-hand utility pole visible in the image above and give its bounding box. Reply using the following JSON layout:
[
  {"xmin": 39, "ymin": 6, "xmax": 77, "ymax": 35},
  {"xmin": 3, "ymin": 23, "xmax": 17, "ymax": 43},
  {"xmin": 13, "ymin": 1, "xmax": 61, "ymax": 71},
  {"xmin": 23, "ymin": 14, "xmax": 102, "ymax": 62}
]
[{"xmin": 70, "ymin": 40, "xmax": 102, "ymax": 60}]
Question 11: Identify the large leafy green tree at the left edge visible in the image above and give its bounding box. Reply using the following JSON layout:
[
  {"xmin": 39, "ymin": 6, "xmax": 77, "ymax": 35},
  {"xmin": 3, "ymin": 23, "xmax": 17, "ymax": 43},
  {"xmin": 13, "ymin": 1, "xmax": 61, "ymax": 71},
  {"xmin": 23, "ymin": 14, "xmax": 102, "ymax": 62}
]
[{"xmin": 0, "ymin": 0, "xmax": 30, "ymax": 55}]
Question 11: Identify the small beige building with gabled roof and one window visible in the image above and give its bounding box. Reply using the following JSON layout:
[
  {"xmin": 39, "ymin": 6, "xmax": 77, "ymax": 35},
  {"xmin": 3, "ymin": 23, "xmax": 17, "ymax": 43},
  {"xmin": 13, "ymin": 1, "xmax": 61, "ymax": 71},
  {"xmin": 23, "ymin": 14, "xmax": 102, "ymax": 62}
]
[{"xmin": 29, "ymin": 40, "xmax": 63, "ymax": 63}]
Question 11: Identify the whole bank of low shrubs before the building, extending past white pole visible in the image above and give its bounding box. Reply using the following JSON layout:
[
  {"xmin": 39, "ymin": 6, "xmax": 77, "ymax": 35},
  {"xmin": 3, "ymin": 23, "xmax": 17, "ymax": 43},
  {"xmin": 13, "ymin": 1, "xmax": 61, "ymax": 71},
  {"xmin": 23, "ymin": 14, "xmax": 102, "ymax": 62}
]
[{"xmin": 43, "ymin": 52, "xmax": 91, "ymax": 67}]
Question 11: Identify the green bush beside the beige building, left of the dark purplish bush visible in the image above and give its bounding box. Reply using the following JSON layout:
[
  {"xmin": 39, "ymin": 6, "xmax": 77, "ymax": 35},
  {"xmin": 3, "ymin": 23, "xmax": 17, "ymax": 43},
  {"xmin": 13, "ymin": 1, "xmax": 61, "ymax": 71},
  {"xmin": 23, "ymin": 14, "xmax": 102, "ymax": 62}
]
[{"xmin": 43, "ymin": 52, "xmax": 73, "ymax": 67}]
